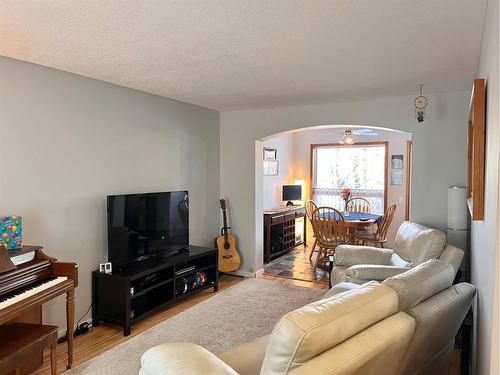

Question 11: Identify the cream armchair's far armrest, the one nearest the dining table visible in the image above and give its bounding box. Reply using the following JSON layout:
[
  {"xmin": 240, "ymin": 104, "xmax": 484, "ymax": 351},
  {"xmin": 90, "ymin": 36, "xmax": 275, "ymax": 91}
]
[{"xmin": 334, "ymin": 245, "xmax": 393, "ymax": 267}]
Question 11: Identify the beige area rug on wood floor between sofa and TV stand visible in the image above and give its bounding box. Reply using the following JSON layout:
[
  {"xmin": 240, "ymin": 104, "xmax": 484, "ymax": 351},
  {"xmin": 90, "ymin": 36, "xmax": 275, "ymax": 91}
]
[{"xmin": 66, "ymin": 279, "xmax": 325, "ymax": 375}]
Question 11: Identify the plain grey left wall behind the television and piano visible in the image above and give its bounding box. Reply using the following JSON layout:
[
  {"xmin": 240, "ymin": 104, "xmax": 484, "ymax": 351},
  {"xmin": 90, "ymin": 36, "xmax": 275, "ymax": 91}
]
[{"xmin": 0, "ymin": 57, "xmax": 220, "ymax": 332}]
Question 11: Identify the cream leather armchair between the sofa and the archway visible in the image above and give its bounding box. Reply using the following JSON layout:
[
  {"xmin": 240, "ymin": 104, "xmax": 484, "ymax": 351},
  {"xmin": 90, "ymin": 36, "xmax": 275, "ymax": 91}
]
[{"xmin": 330, "ymin": 221, "xmax": 464, "ymax": 286}]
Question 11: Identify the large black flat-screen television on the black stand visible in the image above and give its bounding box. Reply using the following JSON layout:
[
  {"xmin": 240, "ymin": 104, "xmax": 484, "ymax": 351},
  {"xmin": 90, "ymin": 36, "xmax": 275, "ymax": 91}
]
[{"xmin": 107, "ymin": 191, "xmax": 189, "ymax": 268}]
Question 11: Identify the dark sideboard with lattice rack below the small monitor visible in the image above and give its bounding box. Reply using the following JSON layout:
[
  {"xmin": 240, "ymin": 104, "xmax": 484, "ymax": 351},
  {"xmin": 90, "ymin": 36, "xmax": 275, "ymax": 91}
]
[{"xmin": 264, "ymin": 206, "xmax": 307, "ymax": 263}]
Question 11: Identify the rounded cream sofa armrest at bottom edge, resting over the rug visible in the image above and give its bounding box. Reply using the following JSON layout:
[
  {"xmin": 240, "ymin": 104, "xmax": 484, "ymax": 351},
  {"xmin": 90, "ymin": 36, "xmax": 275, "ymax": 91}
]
[{"xmin": 139, "ymin": 342, "xmax": 238, "ymax": 375}]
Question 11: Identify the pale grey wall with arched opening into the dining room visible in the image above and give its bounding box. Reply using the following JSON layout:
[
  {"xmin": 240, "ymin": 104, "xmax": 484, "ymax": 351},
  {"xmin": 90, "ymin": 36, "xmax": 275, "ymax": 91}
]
[{"xmin": 220, "ymin": 92, "xmax": 469, "ymax": 272}]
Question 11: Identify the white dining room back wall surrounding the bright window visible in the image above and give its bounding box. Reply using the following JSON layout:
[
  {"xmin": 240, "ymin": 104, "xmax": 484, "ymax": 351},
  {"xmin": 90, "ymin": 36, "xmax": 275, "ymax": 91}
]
[{"xmin": 293, "ymin": 127, "xmax": 411, "ymax": 246}]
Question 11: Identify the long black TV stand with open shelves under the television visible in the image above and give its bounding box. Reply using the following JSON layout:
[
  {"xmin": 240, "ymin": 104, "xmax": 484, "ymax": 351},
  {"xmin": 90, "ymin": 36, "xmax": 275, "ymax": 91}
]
[{"xmin": 92, "ymin": 246, "xmax": 219, "ymax": 336}]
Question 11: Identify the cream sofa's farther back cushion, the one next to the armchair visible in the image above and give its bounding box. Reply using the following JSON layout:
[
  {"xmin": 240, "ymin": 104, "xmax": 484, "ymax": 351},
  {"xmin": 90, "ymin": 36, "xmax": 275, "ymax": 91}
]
[{"xmin": 382, "ymin": 259, "xmax": 455, "ymax": 311}]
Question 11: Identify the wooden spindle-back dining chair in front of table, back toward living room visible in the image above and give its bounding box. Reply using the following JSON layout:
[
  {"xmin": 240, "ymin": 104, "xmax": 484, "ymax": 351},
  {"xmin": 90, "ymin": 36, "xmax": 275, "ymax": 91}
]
[{"xmin": 311, "ymin": 207, "xmax": 349, "ymax": 269}]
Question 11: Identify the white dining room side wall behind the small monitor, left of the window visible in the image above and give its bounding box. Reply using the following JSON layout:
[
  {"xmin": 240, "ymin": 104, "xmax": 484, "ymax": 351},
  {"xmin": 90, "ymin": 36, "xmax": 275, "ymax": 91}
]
[{"xmin": 260, "ymin": 134, "xmax": 294, "ymax": 208}]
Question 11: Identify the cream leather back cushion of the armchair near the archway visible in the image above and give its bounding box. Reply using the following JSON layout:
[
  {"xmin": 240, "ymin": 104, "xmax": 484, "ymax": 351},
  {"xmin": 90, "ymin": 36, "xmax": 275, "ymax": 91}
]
[{"xmin": 394, "ymin": 221, "xmax": 446, "ymax": 267}]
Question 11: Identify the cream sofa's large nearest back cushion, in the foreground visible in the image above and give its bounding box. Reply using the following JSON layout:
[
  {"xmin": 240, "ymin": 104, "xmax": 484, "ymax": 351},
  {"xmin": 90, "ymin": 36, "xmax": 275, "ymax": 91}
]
[{"xmin": 261, "ymin": 281, "xmax": 398, "ymax": 375}]
